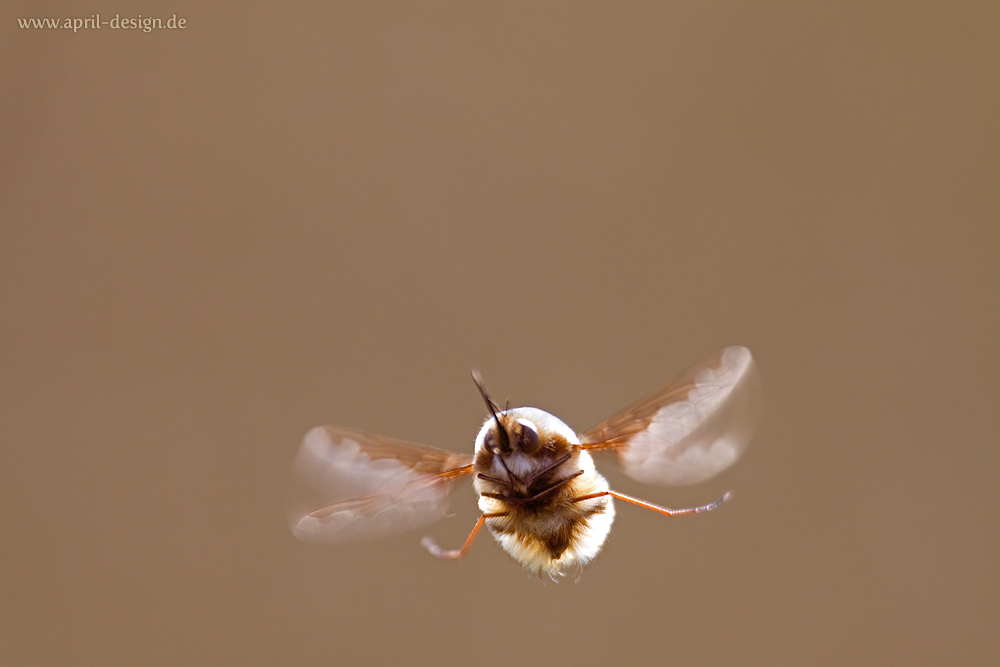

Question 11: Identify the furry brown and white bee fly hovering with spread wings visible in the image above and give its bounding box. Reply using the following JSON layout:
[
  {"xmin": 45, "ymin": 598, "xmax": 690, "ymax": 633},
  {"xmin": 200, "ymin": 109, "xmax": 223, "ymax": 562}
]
[{"xmin": 291, "ymin": 347, "xmax": 761, "ymax": 578}]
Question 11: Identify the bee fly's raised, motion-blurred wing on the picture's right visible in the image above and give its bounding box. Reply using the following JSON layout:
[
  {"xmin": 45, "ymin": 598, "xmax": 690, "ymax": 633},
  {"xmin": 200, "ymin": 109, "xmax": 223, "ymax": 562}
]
[{"xmin": 580, "ymin": 346, "xmax": 763, "ymax": 485}]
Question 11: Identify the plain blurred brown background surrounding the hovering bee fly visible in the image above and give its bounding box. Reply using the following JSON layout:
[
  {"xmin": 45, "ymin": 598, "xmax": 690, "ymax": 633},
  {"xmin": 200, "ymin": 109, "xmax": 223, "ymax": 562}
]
[{"xmin": 0, "ymin": 1, "xmax": 1000, "ymax": 666}]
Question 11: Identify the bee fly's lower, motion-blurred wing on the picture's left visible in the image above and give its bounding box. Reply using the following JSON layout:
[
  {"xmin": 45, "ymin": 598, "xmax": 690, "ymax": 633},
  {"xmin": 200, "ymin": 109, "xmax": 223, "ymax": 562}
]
[{"xmin": 289, "ymin": 426, "xmax": 472, "ymax": 542}]
